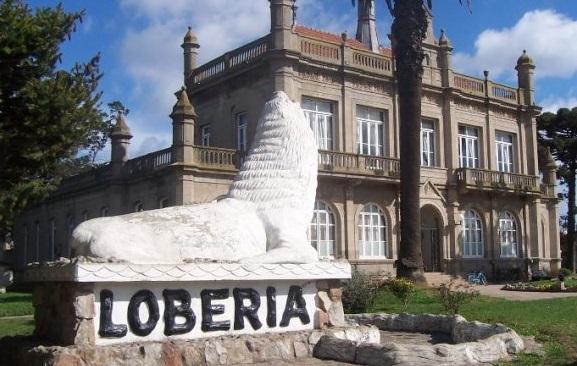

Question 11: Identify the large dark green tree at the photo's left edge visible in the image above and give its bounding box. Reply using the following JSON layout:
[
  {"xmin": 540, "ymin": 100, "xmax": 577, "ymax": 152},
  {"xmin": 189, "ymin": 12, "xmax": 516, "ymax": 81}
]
[{"xmin": 0, "ymin": 0, "xmax": 116, "ymax": 235}]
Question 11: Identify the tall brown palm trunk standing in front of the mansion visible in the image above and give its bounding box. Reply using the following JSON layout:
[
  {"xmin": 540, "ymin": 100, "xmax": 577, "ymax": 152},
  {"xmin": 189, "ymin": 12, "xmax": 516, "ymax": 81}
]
[{"xmin": 392, "ymin": 0, "xmax": 427, "ymax": 282}]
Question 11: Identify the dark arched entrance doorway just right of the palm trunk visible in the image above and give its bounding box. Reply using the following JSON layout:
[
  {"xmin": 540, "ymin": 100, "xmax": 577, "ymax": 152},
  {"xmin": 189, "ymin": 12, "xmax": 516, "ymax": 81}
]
[{"xmin": 421, "ymin": 206, "xmax": 442, "ymax": 272}]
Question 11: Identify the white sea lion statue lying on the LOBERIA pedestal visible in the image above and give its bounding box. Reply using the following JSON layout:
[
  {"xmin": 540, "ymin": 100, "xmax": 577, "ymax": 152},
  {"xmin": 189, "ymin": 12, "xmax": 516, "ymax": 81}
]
[{"xmin": 71, "ymin": 92, "xmax": 318, "ymax": 264}]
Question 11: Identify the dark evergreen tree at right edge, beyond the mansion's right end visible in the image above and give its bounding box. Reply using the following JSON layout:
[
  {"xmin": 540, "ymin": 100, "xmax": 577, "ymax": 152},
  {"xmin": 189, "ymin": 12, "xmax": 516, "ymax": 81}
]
[{"xmin": 537, "ymin": 107, "xmax": 577, "ymax": 271}]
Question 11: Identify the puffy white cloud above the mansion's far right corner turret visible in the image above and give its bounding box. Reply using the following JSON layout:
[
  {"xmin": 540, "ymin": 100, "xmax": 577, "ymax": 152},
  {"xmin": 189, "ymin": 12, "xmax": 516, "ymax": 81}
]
[{"xmin": 454, "ymin": 10, "xmax": 577, "ymax": 79}]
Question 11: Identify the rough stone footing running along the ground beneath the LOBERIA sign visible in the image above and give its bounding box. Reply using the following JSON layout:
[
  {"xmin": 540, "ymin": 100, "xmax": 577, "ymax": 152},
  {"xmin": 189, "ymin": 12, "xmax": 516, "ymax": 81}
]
[{"xmin": 0, "ymin": 326, "xmax": 380, "ymax": 366}]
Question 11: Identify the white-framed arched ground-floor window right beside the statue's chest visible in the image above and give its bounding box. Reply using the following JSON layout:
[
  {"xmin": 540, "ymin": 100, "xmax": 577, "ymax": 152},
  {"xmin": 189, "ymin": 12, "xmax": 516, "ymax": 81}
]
[{"xmin": 308, "ymin": 201, "xmax": 335, "ymax": 258}]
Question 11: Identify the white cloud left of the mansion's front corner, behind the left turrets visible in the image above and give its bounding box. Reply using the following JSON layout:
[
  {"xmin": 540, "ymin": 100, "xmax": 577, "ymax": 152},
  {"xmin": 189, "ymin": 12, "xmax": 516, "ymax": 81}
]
[{"xmin": 120, "ymin": 0, "xmax": 270, "ymax": 156}]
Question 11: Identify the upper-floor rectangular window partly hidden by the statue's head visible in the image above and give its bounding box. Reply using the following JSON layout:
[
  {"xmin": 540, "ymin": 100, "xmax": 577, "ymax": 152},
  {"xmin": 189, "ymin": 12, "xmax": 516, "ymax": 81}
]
[{"xmin": 302, "ymin": 98, "xmax": 334, "ymax": 150}]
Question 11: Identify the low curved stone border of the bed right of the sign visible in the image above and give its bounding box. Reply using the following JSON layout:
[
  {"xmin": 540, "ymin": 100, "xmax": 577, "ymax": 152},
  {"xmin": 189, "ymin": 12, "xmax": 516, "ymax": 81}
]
[{"xmin": 313, "ymin": 314, "xmax": 525, "ymax": 366}]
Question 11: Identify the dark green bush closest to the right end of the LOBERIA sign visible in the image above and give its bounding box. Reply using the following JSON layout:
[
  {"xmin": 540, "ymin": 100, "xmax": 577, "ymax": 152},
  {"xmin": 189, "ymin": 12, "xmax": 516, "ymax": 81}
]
[{"xmin": 343, "ymin": 270, "xmax": 377, "ymax": 314}]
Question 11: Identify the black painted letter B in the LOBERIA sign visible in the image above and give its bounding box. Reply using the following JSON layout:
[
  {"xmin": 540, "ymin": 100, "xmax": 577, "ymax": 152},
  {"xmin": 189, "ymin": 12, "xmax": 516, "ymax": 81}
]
[{"xmin": 162, "ymin": 290, "xmax": 196, "ymax": 336}]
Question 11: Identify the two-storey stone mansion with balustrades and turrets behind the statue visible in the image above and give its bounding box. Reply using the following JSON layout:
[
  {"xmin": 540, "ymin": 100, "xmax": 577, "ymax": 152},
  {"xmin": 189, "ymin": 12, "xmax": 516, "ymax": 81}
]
[{"xmin": 15, "ymin": 0, "xmax": 561, "ymax": 278}]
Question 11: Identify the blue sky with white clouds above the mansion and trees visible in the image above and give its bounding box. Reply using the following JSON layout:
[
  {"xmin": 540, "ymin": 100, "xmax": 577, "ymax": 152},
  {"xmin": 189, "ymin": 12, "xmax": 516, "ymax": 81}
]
[{"xmin": 27, "ymin": 0, "xmax": 577, "ymax": 161}]
